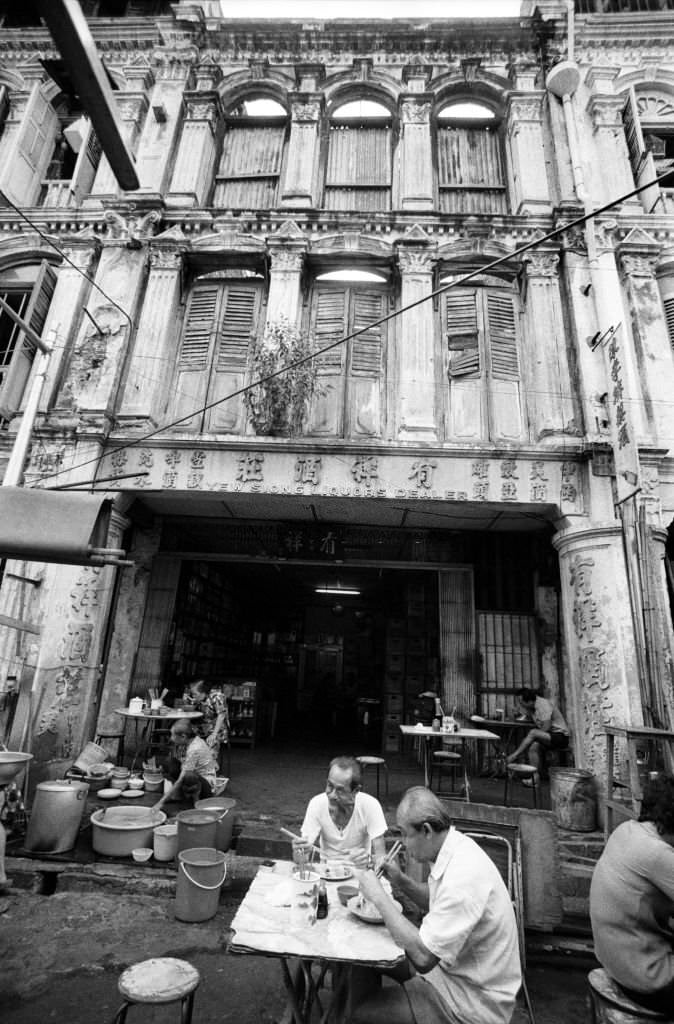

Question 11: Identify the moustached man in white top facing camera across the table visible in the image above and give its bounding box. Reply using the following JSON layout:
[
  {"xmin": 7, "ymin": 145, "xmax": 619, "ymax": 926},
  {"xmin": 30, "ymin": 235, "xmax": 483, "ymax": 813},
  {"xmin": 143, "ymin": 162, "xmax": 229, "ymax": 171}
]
[{"xmin": 293, "ymin": 757, "xmax": 387, "ymax": 866}]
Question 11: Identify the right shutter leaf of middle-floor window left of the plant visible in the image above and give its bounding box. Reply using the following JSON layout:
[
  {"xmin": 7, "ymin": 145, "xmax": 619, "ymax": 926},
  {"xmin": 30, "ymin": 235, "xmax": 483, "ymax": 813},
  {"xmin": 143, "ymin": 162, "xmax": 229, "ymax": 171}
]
[{"xmin": 205, "ymin": 282, "xmax": 261, "ymax": 433}]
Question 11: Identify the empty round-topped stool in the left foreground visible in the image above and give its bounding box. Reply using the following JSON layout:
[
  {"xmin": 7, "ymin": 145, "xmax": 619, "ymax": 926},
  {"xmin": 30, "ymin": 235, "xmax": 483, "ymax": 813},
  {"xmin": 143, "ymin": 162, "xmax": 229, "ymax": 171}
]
[{"xmin": 114, "ymin": 956, "xmax": 201, "ymax": 1024}]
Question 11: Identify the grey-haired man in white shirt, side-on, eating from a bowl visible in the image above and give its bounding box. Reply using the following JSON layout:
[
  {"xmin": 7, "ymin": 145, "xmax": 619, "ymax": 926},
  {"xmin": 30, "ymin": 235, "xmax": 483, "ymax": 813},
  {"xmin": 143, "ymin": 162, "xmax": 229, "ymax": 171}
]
[{"xmin": 352, "ymin": 785, "xmax": 521, "ymax": 1024}]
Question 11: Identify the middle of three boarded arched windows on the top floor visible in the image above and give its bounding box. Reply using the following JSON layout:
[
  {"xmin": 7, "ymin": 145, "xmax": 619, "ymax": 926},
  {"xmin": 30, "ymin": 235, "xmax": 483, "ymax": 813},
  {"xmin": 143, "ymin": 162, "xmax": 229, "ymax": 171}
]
[{"xmin": 324, "ymin": 99, "xmax": 392, "ymax": 212}]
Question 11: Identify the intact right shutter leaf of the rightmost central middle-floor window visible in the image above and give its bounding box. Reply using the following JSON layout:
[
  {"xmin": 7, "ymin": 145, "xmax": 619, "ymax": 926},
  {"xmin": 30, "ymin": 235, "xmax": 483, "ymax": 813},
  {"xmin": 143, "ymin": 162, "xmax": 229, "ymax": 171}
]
[{"xmin": 483, "ymin": 291, "xmax": 522, "ymax": 441}]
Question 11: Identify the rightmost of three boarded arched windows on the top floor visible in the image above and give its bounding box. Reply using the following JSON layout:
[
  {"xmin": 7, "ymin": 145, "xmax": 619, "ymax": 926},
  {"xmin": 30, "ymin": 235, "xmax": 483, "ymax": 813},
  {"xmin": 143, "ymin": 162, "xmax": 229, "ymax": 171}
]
[{"xmin": 436, "ymin": 100, "xmax": 507, "ymax": 213}]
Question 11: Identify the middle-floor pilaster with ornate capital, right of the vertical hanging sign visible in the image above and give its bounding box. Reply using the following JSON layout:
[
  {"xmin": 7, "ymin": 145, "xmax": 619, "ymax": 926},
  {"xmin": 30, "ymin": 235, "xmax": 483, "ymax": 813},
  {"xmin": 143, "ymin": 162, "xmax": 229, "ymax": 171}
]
[{"xmin": 618, "ymin": 240, "xmax": 674, "ymax": 447}]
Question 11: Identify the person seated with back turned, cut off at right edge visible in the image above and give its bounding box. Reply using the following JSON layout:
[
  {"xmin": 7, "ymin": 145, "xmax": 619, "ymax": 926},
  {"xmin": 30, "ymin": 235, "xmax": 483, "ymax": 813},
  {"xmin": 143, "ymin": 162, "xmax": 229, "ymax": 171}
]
[{"xmin": 590, "ymin": 772, "xmax": 674, "ymax": 1019}]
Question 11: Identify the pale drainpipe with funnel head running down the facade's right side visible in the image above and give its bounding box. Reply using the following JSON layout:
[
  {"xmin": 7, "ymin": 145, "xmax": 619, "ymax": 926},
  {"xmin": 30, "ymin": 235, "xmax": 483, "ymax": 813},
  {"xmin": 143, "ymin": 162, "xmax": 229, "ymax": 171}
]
[{"xmin": 545, "ymin": 6, "xmax": 665, "ymax": 727}]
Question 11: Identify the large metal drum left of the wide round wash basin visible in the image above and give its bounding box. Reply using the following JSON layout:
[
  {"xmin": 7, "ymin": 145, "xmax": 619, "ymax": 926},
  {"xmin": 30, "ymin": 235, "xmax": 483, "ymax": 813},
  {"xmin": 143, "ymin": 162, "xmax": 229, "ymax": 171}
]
[{"xmin": 26, "ymin": 779, "xmax": 89, "ymax": 853}]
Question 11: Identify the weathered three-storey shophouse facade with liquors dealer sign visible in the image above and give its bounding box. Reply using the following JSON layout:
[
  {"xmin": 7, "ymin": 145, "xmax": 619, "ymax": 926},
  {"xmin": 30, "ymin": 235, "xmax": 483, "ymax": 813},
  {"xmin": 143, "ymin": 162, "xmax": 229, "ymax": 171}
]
[{"xmin": 0, "ymin": 0, "xmax": 674, "ymax": 798}]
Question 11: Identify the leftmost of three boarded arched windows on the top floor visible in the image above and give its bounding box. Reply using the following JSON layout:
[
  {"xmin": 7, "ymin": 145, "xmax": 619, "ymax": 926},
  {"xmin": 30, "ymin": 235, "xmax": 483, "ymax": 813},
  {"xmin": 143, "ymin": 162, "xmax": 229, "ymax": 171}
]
[{"xmin": 213, "ymin": 97, "xmax": 288, "ymax": 210}]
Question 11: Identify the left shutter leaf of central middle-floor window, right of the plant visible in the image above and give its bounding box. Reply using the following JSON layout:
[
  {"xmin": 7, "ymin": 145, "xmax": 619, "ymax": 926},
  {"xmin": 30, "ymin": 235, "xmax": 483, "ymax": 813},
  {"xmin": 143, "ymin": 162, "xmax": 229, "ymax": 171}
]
[{"xmin": 308, "ymin": 285, "xmax": 348, "ymax": 436}]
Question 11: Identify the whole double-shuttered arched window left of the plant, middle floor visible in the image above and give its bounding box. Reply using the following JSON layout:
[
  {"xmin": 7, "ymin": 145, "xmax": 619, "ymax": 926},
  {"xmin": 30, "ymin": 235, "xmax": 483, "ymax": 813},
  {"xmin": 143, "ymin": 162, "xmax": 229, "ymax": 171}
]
[{"xmin": 171, "ymin": 270, "xmax": 263, "ymax": 433}]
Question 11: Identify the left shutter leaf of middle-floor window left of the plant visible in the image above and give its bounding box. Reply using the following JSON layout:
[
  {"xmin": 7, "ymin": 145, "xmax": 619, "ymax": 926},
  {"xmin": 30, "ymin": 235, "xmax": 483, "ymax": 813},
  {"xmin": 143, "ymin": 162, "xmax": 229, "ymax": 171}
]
[{"xmin": 174, "ymin": 282, "xmax": 222, "ymax": 430}]
